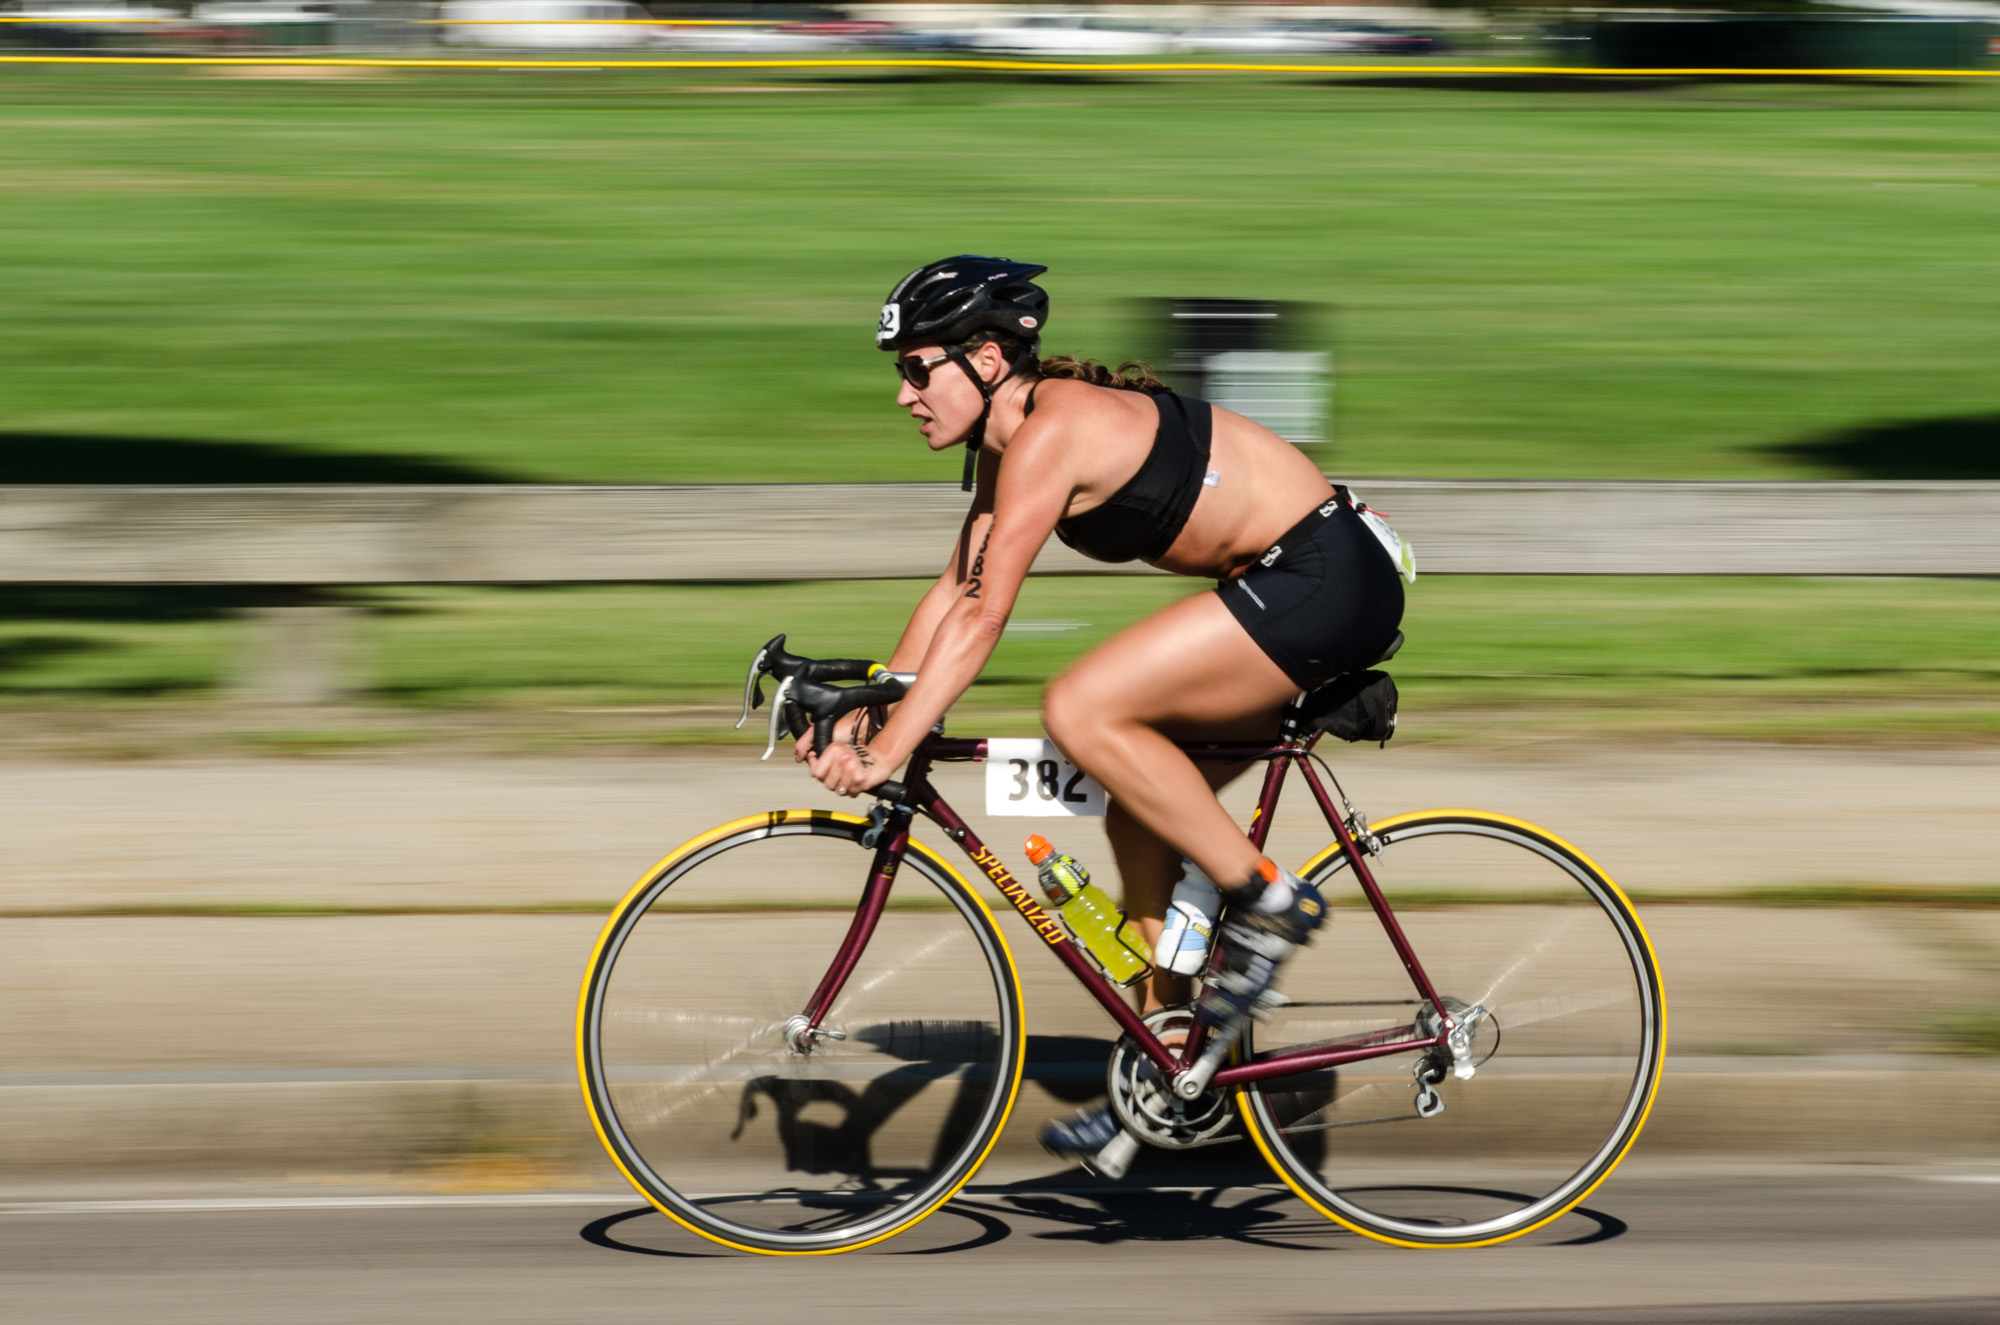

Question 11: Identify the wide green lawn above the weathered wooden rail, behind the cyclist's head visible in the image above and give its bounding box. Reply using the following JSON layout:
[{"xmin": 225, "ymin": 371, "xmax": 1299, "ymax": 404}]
[{"xmin": 0, "ymin": 68, "xmax": 2000, "ymax": 482}]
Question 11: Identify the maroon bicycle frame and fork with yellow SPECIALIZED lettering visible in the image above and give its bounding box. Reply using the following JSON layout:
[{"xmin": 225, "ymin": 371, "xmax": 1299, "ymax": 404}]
[{"xmin": 806, "ymin": 733, "xmax": 1452, "ymax": 1087}]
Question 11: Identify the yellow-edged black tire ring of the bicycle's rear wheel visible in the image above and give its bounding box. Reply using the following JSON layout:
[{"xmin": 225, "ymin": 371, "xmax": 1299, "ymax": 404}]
[{"xmin": 1236, "ymin": 811, "xmax": 1666, "ymax": 1247}]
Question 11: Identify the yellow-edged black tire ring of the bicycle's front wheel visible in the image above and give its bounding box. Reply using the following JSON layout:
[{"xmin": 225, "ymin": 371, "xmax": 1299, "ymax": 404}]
[{"xmin": 576, "ymin": 811, "xmax": 1026, "ymax": 1255}]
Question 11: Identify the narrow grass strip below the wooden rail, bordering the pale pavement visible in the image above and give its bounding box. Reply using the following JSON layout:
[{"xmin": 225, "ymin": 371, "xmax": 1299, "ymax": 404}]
[{"xmin": 0, "ymin": 576, "xmax": 2000, "ymax": 753}]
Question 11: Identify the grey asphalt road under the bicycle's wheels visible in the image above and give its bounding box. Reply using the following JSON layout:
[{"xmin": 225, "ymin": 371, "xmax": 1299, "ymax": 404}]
[{"xmin": 0, "ymin": 1165, "xmax": 2000, "ymax": 1325}]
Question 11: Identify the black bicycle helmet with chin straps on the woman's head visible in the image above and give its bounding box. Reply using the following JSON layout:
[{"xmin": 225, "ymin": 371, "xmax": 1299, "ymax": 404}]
[{"xmin": 876, "ymin": 252, "xmax": 1048, "ymax": 492}]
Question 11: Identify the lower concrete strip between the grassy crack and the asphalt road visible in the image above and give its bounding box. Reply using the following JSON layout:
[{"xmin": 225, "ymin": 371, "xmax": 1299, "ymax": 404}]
[{"xmin": 0, "ymin": 907, "xmax": 2000, "ymax": 1181}]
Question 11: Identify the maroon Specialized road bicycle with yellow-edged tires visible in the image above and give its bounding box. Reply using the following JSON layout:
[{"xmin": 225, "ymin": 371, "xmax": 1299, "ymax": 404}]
[{"xmin": 576, "ymin": 634, "xmax": 1666, "ymax": 1255}]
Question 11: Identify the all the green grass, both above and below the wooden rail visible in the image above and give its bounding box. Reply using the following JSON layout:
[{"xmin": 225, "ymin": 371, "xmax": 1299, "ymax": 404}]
[{"xmin": 0, "ymin": 68, "xmax": 2000, "ymax": 751}]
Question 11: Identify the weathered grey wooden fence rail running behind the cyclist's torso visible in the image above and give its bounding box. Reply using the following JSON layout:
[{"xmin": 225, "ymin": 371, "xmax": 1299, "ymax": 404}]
[{"xmin": 0, "ymin": 478, "xmax": 2000, "ymax": 586}]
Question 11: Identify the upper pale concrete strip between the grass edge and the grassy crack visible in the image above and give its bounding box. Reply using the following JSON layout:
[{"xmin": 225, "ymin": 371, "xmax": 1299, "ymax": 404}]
[{"xmin": 0, "ymin": 743, "xmax": 2000, "ymax": 909}]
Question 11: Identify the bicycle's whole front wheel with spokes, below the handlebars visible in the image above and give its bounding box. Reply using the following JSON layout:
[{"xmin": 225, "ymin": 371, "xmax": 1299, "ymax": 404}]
[{"xmin": 578, "ymin": 811, "xmax": 1024, "ymax": 1255}]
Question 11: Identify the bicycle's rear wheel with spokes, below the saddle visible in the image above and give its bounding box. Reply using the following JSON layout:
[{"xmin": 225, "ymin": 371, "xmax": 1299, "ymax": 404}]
[{"xmin": 1238, "ymin": 811, "xmax": 1666, "ymax": 1247}]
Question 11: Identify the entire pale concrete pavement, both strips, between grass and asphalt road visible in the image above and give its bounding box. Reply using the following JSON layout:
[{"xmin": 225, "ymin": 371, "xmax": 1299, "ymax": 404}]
[{"xmin": 0, "ymin": 747, "xmax": 2000, "ymax": 1181}]
